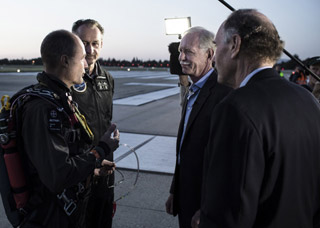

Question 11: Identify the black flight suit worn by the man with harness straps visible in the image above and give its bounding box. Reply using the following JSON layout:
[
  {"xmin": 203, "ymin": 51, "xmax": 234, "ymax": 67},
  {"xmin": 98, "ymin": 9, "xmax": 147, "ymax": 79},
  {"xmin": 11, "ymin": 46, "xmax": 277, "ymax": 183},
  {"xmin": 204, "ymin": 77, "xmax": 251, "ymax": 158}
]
[{"xmin": 18, "ymin": 73, "xmax": 96, "ymax": 228}]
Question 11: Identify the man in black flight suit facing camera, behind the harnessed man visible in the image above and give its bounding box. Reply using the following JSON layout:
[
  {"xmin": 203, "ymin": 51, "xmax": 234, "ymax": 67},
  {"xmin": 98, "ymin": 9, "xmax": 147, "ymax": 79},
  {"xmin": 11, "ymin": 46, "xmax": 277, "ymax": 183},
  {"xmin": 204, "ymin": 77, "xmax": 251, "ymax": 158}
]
[{"xmin": 72, "ymin": 19, "xmax": 114, "ymax": 228}]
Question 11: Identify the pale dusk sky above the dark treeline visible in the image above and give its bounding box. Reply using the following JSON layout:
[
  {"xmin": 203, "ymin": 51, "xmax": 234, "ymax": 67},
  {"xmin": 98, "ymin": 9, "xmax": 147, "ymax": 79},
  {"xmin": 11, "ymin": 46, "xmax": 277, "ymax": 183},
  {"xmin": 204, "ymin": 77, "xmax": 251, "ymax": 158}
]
[{"xmin": 0, "ymin": 0, "xmax": 320, "ymax": 60}]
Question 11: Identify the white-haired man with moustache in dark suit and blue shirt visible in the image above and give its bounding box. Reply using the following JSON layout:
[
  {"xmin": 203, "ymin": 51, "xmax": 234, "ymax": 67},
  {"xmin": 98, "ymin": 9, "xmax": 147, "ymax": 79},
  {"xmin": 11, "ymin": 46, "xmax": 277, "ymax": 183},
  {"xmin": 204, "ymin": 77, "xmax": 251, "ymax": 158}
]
[{"xmin": 166, "ymin": 27, "xmax": 231, "ymax": 228}]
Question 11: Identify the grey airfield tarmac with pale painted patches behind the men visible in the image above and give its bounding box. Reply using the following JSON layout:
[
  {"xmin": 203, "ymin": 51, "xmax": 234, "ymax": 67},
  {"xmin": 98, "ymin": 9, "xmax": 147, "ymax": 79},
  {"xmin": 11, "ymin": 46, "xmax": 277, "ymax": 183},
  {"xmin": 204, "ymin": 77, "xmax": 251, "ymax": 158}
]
[{"xmin": 0, "ymin": 71, "xmax": 181, "ymax": 228}]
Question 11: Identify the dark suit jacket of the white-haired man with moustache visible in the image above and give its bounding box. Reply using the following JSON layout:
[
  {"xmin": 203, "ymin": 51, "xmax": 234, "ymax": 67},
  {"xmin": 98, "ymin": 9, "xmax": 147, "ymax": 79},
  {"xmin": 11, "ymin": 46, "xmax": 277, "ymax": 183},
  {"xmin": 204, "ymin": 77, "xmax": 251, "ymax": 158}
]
[{"xmin": 170, "ymin": 71, "xmax": 231, "ymax": 224}]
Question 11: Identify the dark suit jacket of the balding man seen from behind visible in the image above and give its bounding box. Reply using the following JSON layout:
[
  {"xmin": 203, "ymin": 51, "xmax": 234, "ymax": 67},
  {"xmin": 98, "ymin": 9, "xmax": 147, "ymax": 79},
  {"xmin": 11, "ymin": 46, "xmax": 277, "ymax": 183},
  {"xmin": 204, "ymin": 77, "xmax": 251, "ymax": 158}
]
[{"xmin": 200, "ymin": 69, "xmax": 320, "ymax": 228}]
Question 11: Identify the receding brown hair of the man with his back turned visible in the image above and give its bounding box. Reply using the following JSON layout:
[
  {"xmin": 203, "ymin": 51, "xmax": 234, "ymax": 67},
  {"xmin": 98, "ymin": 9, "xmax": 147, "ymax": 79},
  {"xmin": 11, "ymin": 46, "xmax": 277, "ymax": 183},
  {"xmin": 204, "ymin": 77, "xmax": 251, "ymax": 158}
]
[{"xmin": 224, "ymin": 9, "xmax": 284, "ymax": 61}]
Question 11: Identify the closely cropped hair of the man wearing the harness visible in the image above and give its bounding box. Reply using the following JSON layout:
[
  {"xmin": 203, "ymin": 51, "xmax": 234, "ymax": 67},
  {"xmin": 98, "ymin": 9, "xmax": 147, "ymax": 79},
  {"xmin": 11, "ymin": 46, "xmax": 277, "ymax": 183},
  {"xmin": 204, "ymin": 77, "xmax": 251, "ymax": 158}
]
[{"xmin": 40, "ymin": 30, "xmax": 77, "ymax": 68}]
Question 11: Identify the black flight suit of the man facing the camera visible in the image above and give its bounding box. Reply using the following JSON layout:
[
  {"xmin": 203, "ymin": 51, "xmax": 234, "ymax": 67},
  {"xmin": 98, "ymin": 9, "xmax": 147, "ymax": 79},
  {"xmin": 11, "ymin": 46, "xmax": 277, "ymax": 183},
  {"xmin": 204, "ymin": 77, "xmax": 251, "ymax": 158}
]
[{"xmin": 72, "ymin": 62, "xmax": 114, "ymax": 228}]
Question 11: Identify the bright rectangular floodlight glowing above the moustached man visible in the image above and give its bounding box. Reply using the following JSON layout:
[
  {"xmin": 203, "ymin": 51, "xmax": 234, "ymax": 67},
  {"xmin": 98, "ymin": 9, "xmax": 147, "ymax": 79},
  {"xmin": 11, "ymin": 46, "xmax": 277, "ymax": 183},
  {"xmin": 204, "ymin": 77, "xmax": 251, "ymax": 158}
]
[{"xmin": 164, "ymin": 17, "xmax": 191, "ymax": 37}]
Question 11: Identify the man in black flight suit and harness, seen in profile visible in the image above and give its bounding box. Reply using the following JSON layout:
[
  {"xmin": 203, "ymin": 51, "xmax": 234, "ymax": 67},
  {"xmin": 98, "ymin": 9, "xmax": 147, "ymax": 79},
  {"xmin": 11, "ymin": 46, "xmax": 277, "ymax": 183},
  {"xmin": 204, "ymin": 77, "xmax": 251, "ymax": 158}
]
[{"xmin": 17, "ymin": 30, "xmax": 119, "ymax": 228}]
